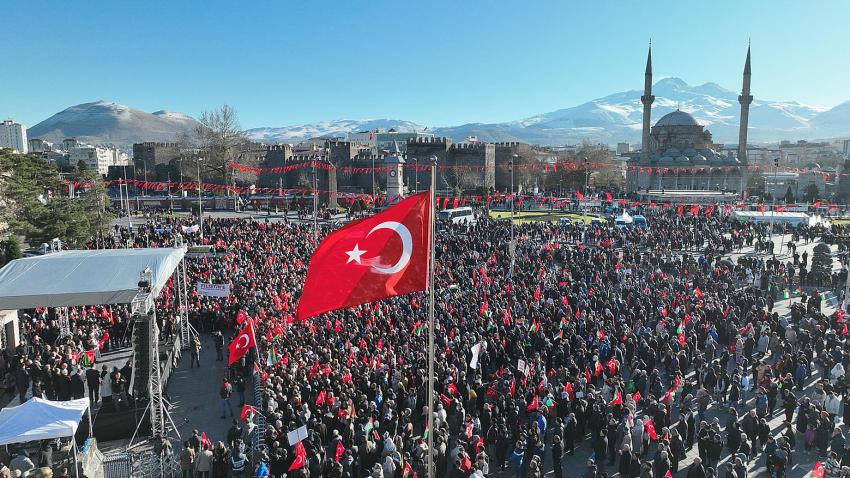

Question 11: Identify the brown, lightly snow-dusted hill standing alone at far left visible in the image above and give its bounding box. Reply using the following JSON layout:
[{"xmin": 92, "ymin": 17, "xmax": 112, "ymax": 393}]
[{"xmin": 27, "ymin": 101, "xmax": 197, "ymax": 149}]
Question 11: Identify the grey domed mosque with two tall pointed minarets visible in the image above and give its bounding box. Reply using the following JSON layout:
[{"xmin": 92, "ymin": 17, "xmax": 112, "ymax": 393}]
[{"xmin": 626, "ymin": 45, "xmax": 753, "ymax": 196}]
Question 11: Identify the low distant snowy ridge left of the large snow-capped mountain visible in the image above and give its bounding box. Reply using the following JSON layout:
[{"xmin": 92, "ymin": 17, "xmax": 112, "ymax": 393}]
[{"xmin": 247, "ymin": 119, "xmax": 425, "ymax": 144}]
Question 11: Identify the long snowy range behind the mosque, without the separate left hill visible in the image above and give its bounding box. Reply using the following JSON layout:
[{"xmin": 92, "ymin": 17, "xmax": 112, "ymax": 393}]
[{"xmin": 243, "ymin": 78, "xmax": 850, "ymax": 145}]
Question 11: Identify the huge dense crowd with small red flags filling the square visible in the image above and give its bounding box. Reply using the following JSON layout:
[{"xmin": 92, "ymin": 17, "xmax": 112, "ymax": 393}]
[{"xmin": 1, "ymin": 204, "xmax": 850, "ymax": 478}]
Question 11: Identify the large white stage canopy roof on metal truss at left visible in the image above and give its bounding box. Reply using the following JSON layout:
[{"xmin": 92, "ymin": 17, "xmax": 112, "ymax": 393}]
[{"xmin": 0, "ymin": 248, "xmax": 186, "ymax": 310}]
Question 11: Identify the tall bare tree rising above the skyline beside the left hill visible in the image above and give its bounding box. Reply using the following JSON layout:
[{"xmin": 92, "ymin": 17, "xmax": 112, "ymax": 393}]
[{"xmin": 195, "ymin": 105, "xmax": 248, "ymax": 184}]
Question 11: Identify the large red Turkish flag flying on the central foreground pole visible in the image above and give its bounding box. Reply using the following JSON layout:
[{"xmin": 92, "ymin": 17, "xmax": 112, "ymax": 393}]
[{"xmin": 296, "ymin": 192, "xmax": 433, "ymax": 320}]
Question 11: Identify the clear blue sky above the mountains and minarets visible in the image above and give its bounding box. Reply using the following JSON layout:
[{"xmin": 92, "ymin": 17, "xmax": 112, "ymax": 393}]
[{"xmin": 0, "ymin": 0, "xmax": 850, "ymax": 128}]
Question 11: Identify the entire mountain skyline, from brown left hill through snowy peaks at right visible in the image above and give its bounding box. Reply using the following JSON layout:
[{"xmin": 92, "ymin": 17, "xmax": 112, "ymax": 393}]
[{"xmin": 27, "ymin": 78, "xmax": 850, "ymax": 147}]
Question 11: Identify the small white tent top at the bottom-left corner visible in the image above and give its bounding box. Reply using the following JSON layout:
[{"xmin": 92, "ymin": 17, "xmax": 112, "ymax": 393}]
[{"xmin": 0, "ymin": 398, "xmax": 89, "ymax": 445}]
